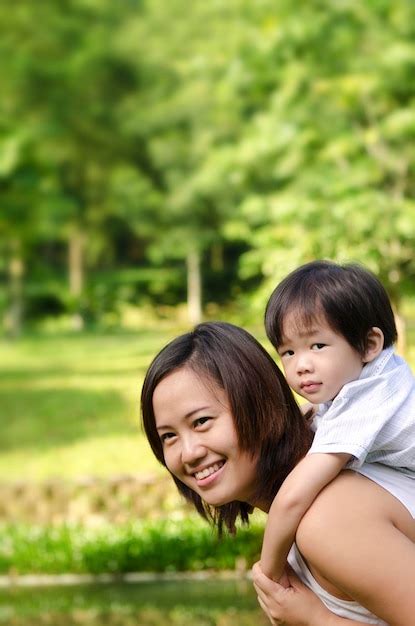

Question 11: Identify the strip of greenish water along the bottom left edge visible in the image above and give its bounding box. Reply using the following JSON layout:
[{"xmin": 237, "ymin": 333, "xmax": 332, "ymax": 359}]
[{"xmin": 0, "ymin": 580, "xmax": 268, "ymax": 626}]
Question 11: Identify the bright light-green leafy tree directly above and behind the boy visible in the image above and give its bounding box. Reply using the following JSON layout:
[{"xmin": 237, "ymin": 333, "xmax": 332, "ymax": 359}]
[{"xmin": 180, "ymin": 0, "xmax": 415, "ymax": 322}]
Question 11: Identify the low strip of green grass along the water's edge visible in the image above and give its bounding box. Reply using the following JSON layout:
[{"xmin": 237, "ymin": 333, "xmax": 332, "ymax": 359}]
[{"xmin": 0, "ymin": 517, "xmax": 263, "ymax": 574}]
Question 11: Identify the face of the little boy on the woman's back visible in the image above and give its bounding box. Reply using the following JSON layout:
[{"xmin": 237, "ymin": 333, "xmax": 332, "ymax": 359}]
[{"xmin": 278, "ymin": 313, "xmax": 363, "ymax": 404}]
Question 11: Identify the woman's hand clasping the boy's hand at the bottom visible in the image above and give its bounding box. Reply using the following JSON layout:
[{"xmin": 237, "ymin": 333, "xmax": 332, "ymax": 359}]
[{"xmin": 252, "ymin": 563, "xmax": 333, "ymax": 626}]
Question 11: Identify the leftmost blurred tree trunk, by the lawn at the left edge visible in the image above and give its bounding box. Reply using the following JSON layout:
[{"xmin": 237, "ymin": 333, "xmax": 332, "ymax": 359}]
[{"xmin": 5, "ymin": 239, "xmax": 24, "ymax": 337}]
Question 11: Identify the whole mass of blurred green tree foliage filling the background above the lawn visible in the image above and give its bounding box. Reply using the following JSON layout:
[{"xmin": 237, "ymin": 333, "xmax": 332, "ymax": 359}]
[{"xmin": 0, "ymin": 0, "xmax": 415, "ymax": 324}]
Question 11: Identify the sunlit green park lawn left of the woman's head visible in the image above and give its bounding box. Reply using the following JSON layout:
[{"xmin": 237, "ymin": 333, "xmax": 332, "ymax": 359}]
[{"xmin": 0, "ymin": 328, "xmax": 177, "ymax": 481}]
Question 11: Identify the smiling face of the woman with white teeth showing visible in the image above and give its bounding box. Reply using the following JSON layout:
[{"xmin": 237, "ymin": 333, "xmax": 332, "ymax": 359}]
[{"xmin": 153, "ymin": 367, "xmax": 256, "ymax": 506}]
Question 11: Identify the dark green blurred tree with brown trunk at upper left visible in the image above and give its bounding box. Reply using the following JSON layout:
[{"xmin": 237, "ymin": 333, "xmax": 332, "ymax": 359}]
[{"xmin": 2, "ymin": 0, "xmax": 161, "ymax": 328}]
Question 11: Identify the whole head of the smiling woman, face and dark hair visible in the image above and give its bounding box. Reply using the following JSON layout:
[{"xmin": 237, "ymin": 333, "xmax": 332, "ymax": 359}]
[{"xmin": 142, "ymin": 322, "xmax": 312, "ymax": 532}]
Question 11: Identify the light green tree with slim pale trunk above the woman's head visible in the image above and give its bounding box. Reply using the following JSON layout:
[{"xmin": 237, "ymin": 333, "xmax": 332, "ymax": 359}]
[{"xmin": 117, "ymin": 0, "xmax": 278, "ymax": 322}]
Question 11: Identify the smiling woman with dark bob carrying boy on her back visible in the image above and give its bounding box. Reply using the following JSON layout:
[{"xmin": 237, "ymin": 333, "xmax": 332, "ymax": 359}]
[{"xmin": 142, "ymin": 322, "xmax": 415, "ymax": 626}]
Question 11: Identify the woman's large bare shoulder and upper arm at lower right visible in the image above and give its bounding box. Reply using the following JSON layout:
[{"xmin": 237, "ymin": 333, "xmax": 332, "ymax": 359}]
[{"xmin": 296, "ymin": 471, "xmax": 415, "ymax": 626}]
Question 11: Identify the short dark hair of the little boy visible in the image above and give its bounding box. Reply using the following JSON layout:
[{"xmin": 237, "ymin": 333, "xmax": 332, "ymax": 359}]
[{"xmin": 265, "ymin": 261, "xmax": 397, "ymax": 355}]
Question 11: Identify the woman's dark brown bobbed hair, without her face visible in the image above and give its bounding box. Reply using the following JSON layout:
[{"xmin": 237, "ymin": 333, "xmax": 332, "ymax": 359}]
[{"xmin": 141, "ymin": 322, "xmax": 312, "ymax": 533}]
